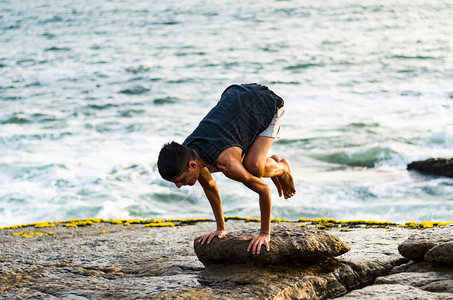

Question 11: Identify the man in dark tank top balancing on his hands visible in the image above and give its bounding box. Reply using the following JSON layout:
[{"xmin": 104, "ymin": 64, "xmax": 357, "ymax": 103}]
[{"xmin": 157, "ymin": 83, "xmax": 296, "ymax": 254}]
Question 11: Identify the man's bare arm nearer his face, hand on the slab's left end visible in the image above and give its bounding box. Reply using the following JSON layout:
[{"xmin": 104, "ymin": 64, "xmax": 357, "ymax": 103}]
[{"xmin": 198, "ymin": 168, "xmax": 225, "ymax": 244}]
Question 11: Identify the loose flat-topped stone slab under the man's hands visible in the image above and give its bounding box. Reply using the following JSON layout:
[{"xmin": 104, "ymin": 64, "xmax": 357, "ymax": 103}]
[{"xmin": 194, "ymin": 226, "xmax": 350, "ymax": 266}]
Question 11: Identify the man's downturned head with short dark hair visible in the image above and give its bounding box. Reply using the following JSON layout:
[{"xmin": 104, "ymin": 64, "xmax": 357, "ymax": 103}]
[{"xmin": 157, "ymin": 142, "xmax": 199, "ymax": 188}]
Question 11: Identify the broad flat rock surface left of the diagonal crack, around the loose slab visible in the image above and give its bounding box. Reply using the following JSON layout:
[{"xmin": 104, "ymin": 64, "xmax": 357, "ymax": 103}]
[{"xmin": 0, "ymin": 220, "xmax": 449, "ymax": 299}]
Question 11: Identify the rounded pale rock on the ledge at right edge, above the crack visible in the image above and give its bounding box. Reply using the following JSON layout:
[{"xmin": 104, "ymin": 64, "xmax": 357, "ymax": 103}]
[{"xmin": 398, "ymin": 224, "xmax": 453, "ymax": 263}]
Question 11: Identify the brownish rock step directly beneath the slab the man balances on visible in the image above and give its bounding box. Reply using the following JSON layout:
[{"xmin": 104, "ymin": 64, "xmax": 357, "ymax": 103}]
[{"xmin": 188, "ymin": 259, "xmax": 400, "ymax": 299}]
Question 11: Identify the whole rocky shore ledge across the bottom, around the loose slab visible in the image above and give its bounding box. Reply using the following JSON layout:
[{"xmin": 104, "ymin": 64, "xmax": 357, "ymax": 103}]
[{"xmin": 0, "ymin": 220, "xmax": 453, "ymax": 299}]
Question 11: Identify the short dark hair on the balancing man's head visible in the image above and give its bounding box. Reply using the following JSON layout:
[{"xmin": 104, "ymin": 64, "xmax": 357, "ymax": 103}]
[{"xmin": 157, "ymin": 142, "xmax": 196, "ymax": 181}]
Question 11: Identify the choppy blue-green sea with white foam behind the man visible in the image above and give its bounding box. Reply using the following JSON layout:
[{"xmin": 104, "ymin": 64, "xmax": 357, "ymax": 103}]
[{"xmin": 0, "ymin": 0, "xmax": 453, "ymax": 225}]
